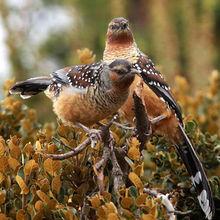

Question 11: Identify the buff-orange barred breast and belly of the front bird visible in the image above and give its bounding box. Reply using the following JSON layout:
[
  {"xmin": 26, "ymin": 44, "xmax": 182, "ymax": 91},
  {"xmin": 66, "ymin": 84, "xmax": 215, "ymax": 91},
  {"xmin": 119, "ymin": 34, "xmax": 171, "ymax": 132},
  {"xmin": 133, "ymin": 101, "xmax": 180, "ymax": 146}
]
[{"xmin": 53, "ymin": 87, "xmax": 129, "ymax": 125}]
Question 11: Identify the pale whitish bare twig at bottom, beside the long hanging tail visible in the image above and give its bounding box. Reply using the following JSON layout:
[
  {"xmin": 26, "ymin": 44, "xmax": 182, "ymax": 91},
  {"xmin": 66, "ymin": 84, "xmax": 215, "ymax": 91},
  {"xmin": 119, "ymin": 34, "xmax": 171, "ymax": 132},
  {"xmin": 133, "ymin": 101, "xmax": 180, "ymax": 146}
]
[{"xmin": 144, "ymin": 188, "xmax": 176, "ymax": 220}]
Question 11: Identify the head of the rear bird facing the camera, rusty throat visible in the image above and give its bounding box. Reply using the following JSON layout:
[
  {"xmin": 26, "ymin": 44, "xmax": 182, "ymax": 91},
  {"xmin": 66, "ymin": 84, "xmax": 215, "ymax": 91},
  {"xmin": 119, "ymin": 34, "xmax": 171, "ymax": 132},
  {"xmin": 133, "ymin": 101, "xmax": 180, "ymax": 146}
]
[{"xmin": 107, "ymin": 17, "xmax": 134, "ymax": 44}]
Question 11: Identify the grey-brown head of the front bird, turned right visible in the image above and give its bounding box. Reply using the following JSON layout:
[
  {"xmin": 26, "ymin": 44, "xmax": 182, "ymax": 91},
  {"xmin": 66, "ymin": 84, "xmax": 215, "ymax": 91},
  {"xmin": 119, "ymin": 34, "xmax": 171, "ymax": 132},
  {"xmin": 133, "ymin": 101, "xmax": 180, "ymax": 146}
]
[{"xmin": 109, "ymin": 59, "xmax": 138, "ymax": 89}]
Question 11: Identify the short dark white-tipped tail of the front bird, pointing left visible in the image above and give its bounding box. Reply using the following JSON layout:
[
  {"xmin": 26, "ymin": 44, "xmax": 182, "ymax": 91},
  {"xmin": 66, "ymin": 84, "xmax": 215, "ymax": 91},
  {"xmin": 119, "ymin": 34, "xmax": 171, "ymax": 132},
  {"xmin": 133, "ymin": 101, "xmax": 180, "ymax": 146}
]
[{"xmin": 9, "ymin": 76, "xmax": 52, "ymax": 99}]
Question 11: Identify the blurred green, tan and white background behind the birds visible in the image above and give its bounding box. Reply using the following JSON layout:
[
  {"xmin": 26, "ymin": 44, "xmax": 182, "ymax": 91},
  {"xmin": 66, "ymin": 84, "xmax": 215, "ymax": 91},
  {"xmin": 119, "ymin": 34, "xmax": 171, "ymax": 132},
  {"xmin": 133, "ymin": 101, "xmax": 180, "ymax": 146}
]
[{"xmin": 0, "ymin": 0, "xmax": 220, "ymax": 120}]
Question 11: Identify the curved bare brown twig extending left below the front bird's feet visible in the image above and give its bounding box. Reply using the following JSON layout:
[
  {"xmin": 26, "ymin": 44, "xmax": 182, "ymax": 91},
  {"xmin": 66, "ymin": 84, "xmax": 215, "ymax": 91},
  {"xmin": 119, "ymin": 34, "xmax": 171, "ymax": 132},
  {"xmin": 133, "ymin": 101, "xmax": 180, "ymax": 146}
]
[{"xmin": 44, "ymin": 138, "xmax": 91, "ymax": 160}]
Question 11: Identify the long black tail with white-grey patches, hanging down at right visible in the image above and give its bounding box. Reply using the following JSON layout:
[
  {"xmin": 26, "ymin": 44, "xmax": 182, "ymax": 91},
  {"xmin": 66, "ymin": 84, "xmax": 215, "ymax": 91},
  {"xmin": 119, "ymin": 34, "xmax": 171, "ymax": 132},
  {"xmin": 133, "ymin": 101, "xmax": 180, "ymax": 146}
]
[{"xmin": 176, "ymin": 124, "xmax": 215, "ymax": 220}]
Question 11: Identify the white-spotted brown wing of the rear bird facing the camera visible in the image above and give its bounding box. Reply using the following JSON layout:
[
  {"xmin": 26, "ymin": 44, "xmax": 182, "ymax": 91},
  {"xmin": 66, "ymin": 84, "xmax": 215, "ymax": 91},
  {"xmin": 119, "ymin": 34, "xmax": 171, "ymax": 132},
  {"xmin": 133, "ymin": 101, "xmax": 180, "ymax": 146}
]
[{"xmin": 134, "ymin": 53, "xmax": 182, "ymax": 124}]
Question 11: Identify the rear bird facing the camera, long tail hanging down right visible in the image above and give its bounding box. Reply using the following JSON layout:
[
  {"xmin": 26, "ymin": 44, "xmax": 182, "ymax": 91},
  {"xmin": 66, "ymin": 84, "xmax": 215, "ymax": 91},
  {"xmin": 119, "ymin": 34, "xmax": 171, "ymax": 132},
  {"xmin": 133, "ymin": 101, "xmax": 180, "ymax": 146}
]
[{"xmin": 103, "ymin": 18, "xmax": 215, "ymax": 219}]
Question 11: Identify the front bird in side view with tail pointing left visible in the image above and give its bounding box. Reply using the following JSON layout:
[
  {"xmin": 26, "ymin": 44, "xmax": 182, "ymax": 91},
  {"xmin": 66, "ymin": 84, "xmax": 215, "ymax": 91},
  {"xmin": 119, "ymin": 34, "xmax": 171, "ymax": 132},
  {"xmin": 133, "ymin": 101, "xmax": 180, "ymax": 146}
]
[{"xmin": 9, "ymin": 59, "xmax": 137, "ymax": 126}]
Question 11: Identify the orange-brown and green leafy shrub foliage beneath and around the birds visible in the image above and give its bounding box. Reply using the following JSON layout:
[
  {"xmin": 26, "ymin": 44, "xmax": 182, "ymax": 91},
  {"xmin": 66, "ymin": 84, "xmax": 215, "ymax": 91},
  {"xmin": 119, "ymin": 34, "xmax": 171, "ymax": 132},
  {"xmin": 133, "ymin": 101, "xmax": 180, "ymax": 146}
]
[{"xmin": 0, "ymin": 49, "xmax": 220, "ymax": 220}]
